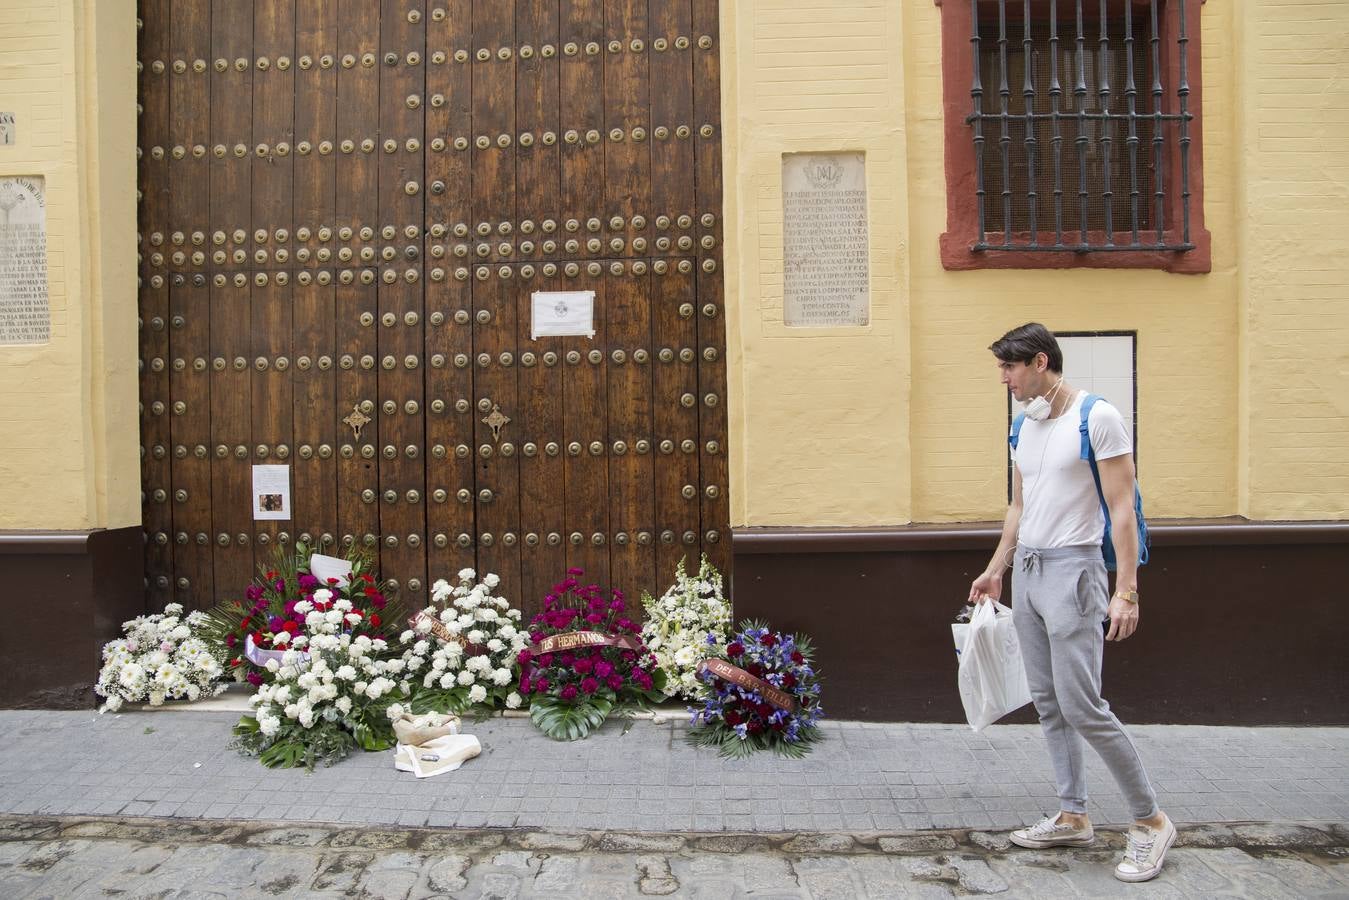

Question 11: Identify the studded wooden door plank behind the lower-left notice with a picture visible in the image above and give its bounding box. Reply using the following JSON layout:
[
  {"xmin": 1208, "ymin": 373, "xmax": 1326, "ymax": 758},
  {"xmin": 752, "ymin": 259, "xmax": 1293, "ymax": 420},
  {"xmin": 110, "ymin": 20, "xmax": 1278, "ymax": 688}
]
[{"xmin": 251, "ymin": 0, "xmax": 295, "ymax": 563}]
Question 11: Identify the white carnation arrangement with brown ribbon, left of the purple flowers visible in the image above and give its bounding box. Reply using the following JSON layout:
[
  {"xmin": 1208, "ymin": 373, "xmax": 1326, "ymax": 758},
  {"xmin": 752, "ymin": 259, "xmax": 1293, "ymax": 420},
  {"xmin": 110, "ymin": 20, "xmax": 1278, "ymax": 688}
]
[{"xmin": 401, "ymin": 568, "xmax": 529, "ymax": 714}]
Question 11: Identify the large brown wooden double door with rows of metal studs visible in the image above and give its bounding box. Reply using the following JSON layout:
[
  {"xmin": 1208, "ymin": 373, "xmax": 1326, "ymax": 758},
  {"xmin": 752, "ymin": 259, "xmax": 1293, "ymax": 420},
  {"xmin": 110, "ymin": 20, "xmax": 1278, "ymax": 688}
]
[{"xmin": 138, "ymin": 0, "xmax": 730, "ymax": 609}]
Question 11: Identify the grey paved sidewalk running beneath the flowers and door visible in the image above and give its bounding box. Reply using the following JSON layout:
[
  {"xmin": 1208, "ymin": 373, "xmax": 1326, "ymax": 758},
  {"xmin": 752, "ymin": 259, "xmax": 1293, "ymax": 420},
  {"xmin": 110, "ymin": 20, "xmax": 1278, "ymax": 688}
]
[{"xmin": 0, "ymin": 710, "xmax": 1349, "ymax": 834}]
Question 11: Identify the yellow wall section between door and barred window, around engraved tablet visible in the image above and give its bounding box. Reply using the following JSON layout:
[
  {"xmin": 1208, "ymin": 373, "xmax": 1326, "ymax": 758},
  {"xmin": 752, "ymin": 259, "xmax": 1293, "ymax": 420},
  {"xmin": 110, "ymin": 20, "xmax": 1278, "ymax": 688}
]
[{"xmin": 722, "ymin": 0, "xmax": 913, "ymax": 525}]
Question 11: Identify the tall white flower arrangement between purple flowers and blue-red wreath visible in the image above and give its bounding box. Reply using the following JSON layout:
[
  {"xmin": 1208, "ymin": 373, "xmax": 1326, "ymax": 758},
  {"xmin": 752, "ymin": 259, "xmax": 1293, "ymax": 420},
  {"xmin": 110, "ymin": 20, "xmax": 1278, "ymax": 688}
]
[{"xmin": 642, "ymin": 556, "xmax": 731, "ymax": 699}]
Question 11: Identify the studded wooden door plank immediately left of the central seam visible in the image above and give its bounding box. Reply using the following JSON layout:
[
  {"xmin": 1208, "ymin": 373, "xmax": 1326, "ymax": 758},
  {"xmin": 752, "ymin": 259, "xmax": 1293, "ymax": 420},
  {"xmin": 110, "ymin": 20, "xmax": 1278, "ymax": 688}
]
[{"xmin": 378, "ymin": 0, "xmax": 426, "ymax": 606}]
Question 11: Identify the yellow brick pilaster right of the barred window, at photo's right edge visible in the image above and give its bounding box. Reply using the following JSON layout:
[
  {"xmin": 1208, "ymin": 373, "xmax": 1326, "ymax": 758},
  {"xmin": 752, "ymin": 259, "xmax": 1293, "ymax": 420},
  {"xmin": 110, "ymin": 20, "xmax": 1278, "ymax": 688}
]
[{"xmin": 1235, "ymin": 0, "xmax": 1349, "ymax": 518}]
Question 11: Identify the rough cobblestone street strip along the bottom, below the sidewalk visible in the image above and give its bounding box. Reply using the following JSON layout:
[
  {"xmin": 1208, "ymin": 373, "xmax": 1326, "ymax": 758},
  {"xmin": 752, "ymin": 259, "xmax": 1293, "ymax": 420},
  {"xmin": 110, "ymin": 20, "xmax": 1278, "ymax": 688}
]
[{"xmin": 0, "ymin": 816, "xmax": 1349, "ymax": 900}]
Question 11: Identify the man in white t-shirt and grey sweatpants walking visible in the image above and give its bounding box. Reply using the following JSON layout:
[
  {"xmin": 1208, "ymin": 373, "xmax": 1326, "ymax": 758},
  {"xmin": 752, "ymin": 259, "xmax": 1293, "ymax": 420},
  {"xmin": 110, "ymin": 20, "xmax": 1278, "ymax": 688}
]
[{"xmin": 970, "ymin": 322, "xmax": 1176, "ymax": 881}]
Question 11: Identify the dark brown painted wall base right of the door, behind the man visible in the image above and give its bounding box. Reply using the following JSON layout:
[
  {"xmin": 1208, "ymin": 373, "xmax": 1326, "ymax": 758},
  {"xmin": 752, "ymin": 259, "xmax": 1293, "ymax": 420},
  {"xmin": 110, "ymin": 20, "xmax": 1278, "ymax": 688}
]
[{"xmin": 731, "ymin": 519, "xmax": 1349, "ymax": 725}]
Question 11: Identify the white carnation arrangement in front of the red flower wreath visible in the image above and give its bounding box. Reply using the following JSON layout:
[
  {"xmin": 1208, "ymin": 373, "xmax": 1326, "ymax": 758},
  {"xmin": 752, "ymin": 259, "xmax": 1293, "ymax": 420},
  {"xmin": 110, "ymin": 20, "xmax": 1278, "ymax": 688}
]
[{"xmin": 235, "ymin": 591, "xmax": 411, "ymax": 769}]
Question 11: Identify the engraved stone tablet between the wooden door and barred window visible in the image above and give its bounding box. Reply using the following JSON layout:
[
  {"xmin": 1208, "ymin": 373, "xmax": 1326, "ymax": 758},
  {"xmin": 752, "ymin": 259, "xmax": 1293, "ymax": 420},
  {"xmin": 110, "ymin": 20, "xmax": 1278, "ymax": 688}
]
[{"xmin": 782, "ymin": 152, "xmax": 871, "ymax": 328}]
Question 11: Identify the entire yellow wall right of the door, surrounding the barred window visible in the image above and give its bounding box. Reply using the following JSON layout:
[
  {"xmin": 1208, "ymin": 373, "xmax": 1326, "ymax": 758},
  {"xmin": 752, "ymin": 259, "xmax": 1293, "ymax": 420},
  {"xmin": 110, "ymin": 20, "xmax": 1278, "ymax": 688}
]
[{"xmin": 723, "ymin": 0, "xmax": 1349, "ymax": 525}]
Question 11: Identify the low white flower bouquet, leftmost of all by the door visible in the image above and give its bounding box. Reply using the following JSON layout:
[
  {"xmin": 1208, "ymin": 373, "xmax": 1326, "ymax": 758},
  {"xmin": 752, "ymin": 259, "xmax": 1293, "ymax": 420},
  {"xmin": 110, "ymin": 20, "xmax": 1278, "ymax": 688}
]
[{"xmin": 93, "ymin": 603, "xmax": 225, "ymax": 712}]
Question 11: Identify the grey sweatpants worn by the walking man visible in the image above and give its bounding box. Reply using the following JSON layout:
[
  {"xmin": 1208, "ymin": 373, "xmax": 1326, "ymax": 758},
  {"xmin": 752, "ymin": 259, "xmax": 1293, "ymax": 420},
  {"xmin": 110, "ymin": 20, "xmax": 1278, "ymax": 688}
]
[{"xmin": 1012, "ymin": 546, "xmax": 1157, "ymax": 819}]
